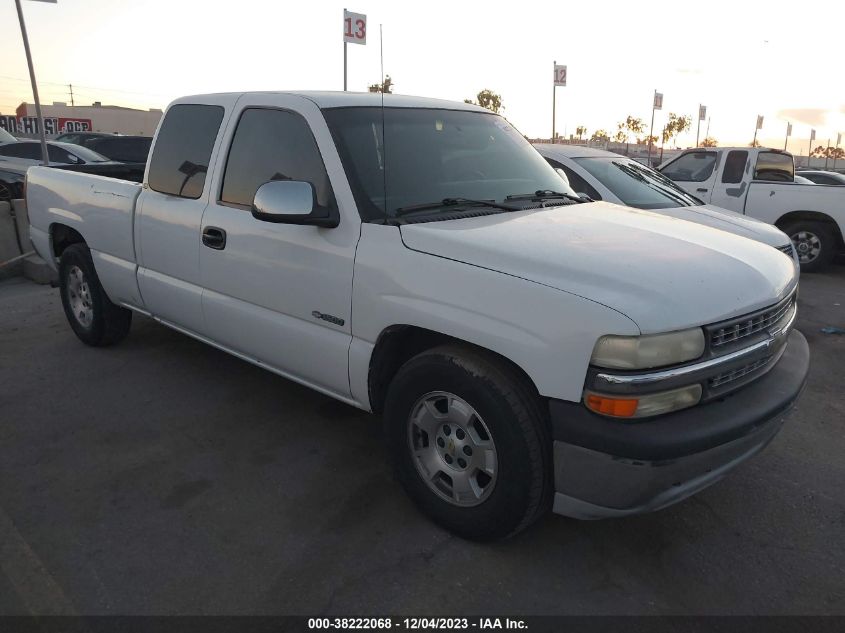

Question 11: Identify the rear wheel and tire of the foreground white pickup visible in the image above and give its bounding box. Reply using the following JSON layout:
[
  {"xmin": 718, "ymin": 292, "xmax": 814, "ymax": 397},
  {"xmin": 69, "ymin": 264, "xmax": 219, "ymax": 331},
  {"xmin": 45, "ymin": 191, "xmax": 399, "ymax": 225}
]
[{"xmin": 59, "ymin": 244, "xmax": 132, "ymax": 347}]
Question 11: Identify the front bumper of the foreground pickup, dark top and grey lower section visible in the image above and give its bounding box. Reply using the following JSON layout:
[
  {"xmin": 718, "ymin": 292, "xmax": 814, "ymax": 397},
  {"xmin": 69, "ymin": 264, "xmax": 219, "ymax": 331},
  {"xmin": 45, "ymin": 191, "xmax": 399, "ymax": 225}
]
[{"xmin": 549, "ymin": 330, "xmax": 810, "ymax": 519}]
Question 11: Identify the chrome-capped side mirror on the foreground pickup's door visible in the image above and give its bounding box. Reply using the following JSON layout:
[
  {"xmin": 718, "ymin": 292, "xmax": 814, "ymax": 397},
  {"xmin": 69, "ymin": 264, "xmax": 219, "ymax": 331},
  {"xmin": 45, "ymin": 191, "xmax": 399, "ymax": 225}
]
[{"xmin": 252, "ymin": 180, "xmax": 338, "ymax": 228}]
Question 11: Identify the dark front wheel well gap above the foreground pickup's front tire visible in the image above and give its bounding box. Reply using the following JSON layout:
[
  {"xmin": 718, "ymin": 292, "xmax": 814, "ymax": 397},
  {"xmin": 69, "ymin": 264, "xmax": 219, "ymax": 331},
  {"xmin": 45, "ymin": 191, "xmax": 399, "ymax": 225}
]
[{"xmin": 368, "ymin": 325, "xmax": 539, "ymax": 413}]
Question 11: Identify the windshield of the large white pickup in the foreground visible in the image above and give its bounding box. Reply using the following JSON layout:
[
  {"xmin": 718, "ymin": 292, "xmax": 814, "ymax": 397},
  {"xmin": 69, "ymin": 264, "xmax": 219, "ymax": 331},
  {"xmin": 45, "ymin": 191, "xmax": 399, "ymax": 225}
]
[{"xmin": 323, "ymin": 107, "xmax": 568, "ymax": 220}]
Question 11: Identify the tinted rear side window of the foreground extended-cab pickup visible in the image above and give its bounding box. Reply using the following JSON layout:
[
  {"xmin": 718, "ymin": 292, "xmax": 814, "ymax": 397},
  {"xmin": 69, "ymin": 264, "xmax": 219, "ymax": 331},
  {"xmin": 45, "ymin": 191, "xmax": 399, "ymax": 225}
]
[{"xmin": 148, "ymin": 104, "xmax": 223, "ymax": 199}]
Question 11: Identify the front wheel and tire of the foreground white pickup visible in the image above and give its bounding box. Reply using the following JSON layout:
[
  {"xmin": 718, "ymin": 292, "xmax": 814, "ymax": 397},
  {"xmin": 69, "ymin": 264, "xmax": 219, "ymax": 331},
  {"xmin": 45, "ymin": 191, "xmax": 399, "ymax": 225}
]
[{"xmin": 384, "ymin": 346, "xmax": 553, "ymax": 541}]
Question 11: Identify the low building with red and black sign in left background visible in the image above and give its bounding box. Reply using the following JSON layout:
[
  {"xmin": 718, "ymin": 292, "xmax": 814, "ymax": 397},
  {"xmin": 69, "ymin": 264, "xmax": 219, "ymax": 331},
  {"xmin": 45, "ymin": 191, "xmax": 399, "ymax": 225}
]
[{"xmin": 0, "ymin": 101, "xmax": 162, "ymax": 138}]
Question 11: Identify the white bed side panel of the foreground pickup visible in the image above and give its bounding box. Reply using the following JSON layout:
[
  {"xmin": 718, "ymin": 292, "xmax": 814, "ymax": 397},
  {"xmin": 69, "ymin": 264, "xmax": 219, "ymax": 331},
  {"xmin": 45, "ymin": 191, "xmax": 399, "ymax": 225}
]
[{"xmin": 26, "ymin": 167, "xmax": 141, "ymax": 304}]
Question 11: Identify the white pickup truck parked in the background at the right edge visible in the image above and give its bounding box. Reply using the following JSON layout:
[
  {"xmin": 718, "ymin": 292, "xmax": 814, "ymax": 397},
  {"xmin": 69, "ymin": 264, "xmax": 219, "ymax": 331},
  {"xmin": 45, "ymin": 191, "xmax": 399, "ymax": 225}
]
[{"xmin": 659, "ymin": 147, "xmax": 845, "ymax": 272}]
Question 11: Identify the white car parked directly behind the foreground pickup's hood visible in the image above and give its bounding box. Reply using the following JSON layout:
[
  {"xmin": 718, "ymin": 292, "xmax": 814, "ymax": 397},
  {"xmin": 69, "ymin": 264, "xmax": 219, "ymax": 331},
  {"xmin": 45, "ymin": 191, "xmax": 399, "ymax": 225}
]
[{"xmin": 534, "ymin": 143, "xmax": 797, "ymax": 262}]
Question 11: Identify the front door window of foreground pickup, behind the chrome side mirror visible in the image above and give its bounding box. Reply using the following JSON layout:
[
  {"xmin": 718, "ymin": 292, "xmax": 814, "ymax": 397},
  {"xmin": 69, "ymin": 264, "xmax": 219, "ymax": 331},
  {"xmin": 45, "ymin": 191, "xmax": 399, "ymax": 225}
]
[{"xmin": 220, "ymin": 108, "xmax": 335, "ymax": 208}]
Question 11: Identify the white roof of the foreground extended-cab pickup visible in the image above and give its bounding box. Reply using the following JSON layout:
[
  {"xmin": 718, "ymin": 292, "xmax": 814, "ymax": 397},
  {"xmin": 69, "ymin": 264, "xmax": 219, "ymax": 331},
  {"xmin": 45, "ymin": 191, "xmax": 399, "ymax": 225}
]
[{"xmin": 174, "ymin": 90, "xmax": 489, "ymax": 112}]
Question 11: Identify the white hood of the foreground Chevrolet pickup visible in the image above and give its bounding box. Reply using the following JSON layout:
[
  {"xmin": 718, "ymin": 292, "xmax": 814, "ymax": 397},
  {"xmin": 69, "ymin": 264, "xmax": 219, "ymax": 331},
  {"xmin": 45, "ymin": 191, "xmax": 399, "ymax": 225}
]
[{"xmin": 400, "ymin": 202, "xmax": 798, "ymax": 334}]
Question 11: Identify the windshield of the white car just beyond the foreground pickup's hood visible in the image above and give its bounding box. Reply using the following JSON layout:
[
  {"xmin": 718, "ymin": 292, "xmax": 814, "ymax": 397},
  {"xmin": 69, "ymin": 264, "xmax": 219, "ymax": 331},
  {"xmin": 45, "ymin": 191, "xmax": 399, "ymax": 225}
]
[{"xmin": 573, "ymin": 156, "xmax": 702, "ymax": 209}]
